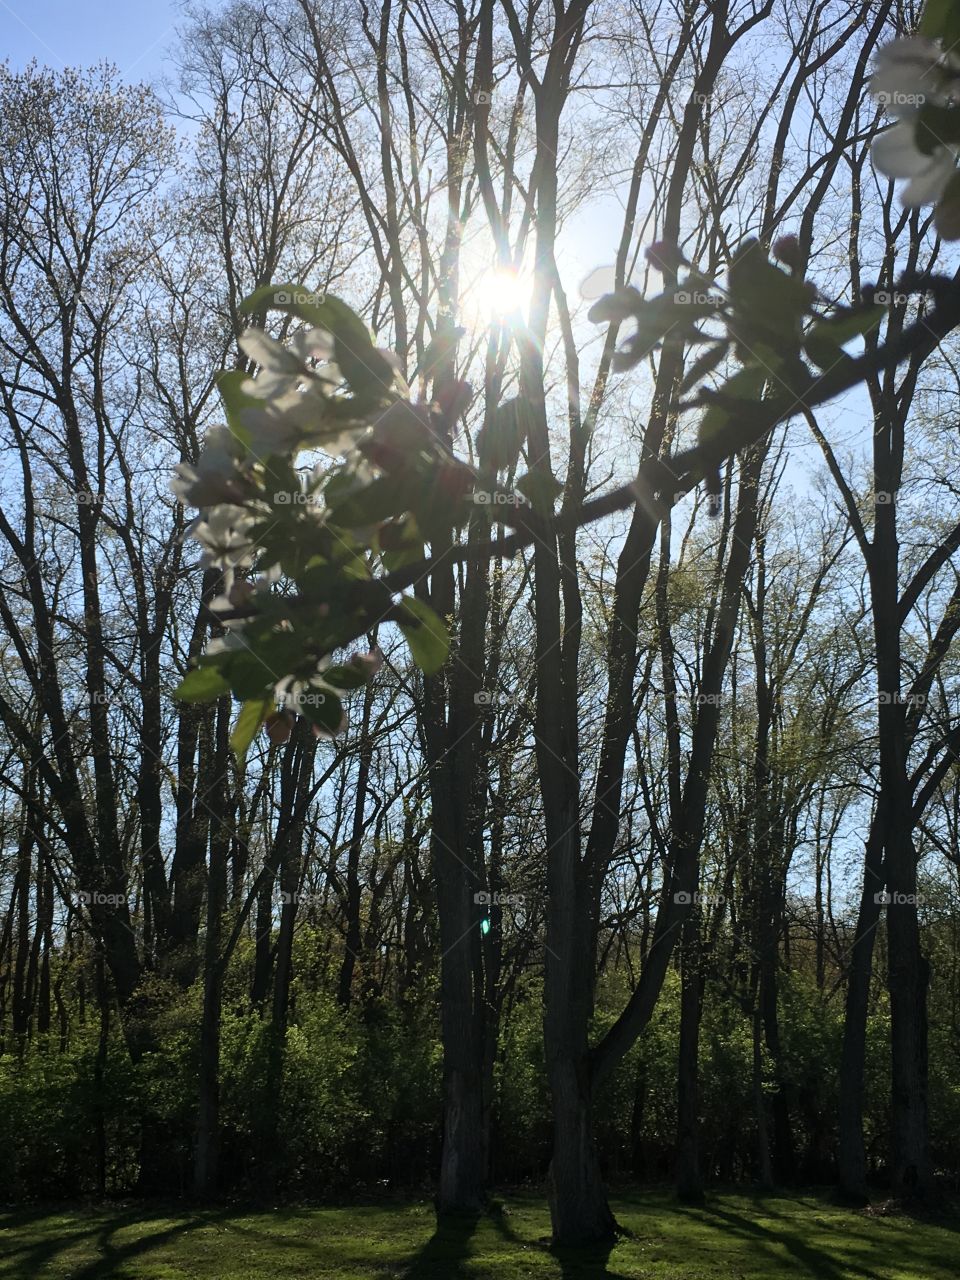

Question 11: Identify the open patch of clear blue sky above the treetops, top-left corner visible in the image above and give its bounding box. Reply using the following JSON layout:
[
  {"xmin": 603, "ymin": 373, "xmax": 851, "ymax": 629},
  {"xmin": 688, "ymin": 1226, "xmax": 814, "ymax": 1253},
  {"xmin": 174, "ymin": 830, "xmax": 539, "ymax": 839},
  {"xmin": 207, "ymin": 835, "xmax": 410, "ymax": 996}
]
[{"xmin": 0, "ymin": 0, "xmax": 180, "ymax": 81}]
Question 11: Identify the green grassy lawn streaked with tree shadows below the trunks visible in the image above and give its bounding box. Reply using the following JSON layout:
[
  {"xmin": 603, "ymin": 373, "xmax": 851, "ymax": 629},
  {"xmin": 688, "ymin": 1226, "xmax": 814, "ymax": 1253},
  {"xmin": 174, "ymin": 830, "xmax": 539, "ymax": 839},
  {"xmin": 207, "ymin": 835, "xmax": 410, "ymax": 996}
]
[{"xmin": 0, "ymin": 1192, "xmax": 960, "ymax": 1280}]
